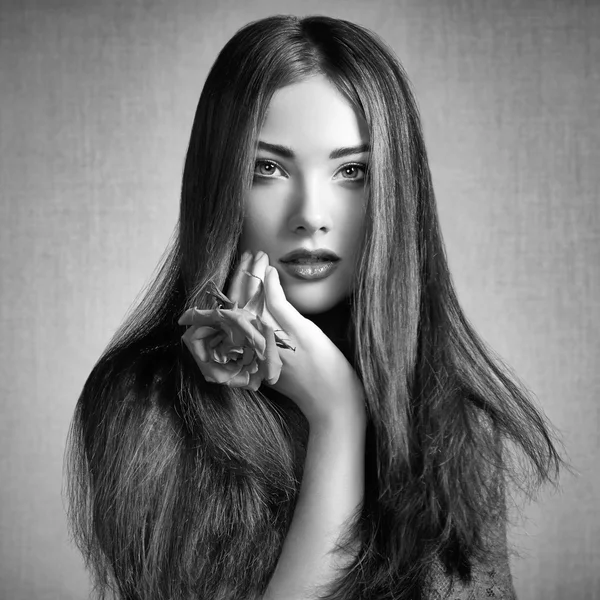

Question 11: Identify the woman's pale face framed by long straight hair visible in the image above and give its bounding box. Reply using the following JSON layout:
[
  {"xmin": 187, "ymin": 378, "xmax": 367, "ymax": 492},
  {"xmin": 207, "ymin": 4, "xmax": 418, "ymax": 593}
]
[{"xmin": 240, "ymin": 76, "xmax": 369, "ymax": 314}]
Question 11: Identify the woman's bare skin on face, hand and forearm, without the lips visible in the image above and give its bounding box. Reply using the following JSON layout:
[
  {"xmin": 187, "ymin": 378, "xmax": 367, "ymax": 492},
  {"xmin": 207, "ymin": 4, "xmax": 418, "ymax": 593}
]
[{"xmin": 227, "ymin": 76, "xmax": 368, "ymax": 600}]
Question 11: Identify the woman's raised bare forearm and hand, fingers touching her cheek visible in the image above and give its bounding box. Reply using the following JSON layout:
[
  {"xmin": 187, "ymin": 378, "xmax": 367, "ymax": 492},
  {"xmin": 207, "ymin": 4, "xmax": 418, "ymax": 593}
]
[{"xmin": 227, "ymin": 253, "xmax": 367, "ymax": 600}]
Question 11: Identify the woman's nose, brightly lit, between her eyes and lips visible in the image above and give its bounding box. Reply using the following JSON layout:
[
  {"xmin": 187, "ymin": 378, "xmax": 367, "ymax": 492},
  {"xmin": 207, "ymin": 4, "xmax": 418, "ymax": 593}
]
[{"xmin": 289, "ymin": 176, "xmax": 333, "ymax": 235}]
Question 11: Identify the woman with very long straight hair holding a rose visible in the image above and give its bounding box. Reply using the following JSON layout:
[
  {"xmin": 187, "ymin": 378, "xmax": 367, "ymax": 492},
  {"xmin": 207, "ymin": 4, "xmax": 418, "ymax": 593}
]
[{"xmin": 70, "ymin": 16, "xmax": 560, "ymax": 600}]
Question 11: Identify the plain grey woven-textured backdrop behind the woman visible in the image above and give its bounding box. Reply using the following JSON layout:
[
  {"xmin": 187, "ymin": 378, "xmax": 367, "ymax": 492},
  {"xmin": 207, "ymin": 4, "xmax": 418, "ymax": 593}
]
[{"xmin": 0, "ymin": 0, "xmax": 600, "ymax": 600}]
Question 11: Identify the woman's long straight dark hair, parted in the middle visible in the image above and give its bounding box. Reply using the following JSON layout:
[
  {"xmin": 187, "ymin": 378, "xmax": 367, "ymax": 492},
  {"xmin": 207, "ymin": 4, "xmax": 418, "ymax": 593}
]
[{"xmin": 68, "ymin": 16, "xmax": 561, "ymax": 600}]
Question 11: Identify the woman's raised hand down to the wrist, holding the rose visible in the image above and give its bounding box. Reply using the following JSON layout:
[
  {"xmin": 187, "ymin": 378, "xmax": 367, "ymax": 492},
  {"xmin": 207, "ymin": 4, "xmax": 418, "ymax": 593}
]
[{"xmin": 226, "ymin": 252, "xmax": 366, "ymax": 426}]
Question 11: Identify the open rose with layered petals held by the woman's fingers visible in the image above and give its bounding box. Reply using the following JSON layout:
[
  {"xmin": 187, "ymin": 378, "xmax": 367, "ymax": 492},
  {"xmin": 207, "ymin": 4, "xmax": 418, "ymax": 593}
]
[{"xmin": 178, "ymin": 273, "xmax": 293, "ymax": 391}]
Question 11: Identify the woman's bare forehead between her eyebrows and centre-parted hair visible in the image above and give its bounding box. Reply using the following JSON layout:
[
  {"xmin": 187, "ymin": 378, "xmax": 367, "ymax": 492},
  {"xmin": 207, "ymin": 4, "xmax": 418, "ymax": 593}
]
[{"xmin": 260, "ymin": 75, "xmax": 369, "ymax": 156}]
